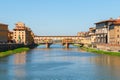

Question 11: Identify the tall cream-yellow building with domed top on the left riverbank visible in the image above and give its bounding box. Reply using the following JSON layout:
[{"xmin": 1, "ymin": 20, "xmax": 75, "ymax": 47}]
[{"xmin": 13, "ymin": 22, "xmax": 34, "ymax": 44}]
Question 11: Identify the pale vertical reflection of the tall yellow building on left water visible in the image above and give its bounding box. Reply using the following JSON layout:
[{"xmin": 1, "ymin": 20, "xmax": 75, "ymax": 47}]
[{"xmin": 10, "ymin": 52, "xmax": 26, "ymax": 79}]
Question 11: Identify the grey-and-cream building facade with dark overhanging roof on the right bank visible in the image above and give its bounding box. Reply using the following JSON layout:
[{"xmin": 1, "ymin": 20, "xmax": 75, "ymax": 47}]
[{"xmin": 95, "ymin": 19, "xmax": 115, "ymax": 44}]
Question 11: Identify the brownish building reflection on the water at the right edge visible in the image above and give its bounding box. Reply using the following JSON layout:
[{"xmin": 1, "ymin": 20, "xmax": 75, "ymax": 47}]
[{"xmin": 90, "ymin": 55, "xmax": 120, "ymax": 80}]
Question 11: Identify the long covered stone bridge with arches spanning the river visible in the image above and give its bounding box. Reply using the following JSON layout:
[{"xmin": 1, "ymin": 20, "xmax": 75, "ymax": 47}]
[{"xmin": 35, "ymin": 36, "xmax": 83, "ymax": 48}]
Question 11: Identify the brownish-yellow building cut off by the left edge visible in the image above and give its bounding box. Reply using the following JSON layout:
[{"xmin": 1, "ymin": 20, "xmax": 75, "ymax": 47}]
[{"xmin": 0, "ymin": 23, "xmax": 8, "ymax": 43}]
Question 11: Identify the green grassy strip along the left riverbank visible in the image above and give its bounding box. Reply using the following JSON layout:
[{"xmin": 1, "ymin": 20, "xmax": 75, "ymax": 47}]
[{"xmin": 0, "ymin": 47, "xmax": 30, "ymax": 58}]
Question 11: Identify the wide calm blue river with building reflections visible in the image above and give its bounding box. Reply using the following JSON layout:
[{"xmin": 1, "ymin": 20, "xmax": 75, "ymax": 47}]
[{"xmin": 0, "ymin": 45, "xmax": 120, "ymax": 80}]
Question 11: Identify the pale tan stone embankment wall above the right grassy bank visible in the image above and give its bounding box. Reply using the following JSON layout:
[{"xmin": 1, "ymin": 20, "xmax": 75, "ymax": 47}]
[{"xmin": 96, "ymin": 44, "xmax": 120, "ymax": 52}]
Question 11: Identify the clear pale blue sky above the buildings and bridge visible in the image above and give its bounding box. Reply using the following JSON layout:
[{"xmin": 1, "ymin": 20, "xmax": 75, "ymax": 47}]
[{"xmin": 0, "ymin": 0, "xmax": 120, "ymax": 35}]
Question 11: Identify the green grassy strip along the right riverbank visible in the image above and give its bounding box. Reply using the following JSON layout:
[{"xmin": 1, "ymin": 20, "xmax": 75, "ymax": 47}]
[{"xmin": 80, "ymin": 47, "xmax": 120, "ymax": 56}]
